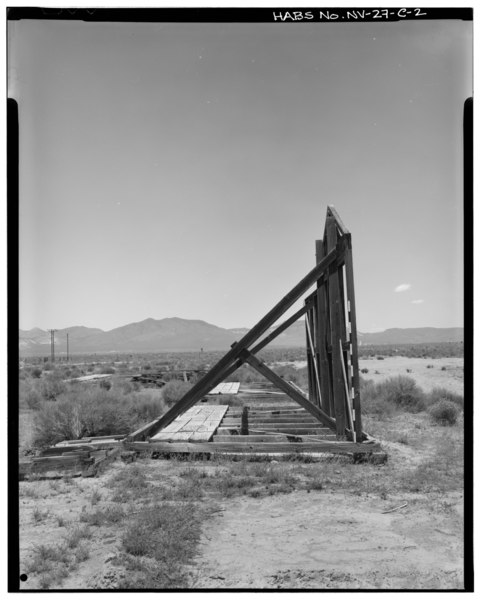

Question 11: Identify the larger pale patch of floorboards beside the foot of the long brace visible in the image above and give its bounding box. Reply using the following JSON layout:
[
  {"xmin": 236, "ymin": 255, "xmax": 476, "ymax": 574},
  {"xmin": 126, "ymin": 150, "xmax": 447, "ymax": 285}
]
[{"xmin": 150, "ymin": 404, "xmax": 229, "ymax": 443}]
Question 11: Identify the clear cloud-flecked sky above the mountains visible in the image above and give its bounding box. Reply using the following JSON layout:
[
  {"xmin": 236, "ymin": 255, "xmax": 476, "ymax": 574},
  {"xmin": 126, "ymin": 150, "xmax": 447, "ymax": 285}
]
[{"xmin": 9, "ymin": 16, "xmax": 472, "ymax": 332}]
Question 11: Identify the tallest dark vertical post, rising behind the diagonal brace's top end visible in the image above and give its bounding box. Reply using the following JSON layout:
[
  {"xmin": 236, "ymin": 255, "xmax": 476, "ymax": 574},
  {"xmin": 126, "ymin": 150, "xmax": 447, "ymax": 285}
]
[{"xmin": 326, "ymin": 217, "xmax": 346, "ymax": 439}]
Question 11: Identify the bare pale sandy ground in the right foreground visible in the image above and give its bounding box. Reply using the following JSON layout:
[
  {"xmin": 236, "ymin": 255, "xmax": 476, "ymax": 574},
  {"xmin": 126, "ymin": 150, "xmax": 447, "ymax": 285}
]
[{"xmin": 196, "ymin": 491, "xmax": 463, "ymax": 589}]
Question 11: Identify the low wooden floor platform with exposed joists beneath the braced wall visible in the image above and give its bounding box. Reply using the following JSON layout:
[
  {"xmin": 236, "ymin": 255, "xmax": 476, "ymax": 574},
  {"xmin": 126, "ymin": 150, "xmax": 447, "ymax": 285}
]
[{"xmin": 135, "ymin": 383, "xmax": 381, "ymax": 456}]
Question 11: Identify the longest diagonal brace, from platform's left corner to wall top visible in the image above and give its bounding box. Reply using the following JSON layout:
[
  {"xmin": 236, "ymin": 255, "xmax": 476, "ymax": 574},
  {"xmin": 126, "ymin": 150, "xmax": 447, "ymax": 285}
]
[{"xmin": 125, "ymin": 240, "xmax": 345, "ymax": 440}]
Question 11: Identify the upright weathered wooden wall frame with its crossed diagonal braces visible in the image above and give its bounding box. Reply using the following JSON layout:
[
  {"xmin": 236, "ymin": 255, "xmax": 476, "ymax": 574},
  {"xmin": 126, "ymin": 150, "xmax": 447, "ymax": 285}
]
[{"xmin": 126, "ymin": 206, "xmax": 368, "ymax": 451}]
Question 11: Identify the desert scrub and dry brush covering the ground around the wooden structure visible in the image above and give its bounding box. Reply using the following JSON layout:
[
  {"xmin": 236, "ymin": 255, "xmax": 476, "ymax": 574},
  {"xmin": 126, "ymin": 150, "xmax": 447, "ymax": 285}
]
[{"xmin": 19, "ymin": 349, "xmax": 464, "ymax": 590}]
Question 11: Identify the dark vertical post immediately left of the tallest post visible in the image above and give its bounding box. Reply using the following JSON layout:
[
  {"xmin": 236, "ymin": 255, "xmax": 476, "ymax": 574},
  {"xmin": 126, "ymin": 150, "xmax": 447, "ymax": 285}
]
[{"xmin": 315, "ymin": 240, "xmax": 334, "ymax": 417}]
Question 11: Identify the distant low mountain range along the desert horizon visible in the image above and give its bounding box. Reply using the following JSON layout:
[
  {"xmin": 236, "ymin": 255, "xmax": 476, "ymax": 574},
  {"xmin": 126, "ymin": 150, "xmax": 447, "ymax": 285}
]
[{"xmin": 19, "ymin": 317, "xmax": 464, "ymax": 356}]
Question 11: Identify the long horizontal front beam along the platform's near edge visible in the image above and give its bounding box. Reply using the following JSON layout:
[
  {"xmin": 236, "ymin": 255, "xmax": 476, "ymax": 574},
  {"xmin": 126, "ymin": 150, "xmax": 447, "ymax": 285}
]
[{"xmin": 125, "ymin": 440, "xmax": 381, "ymax": 454}]
